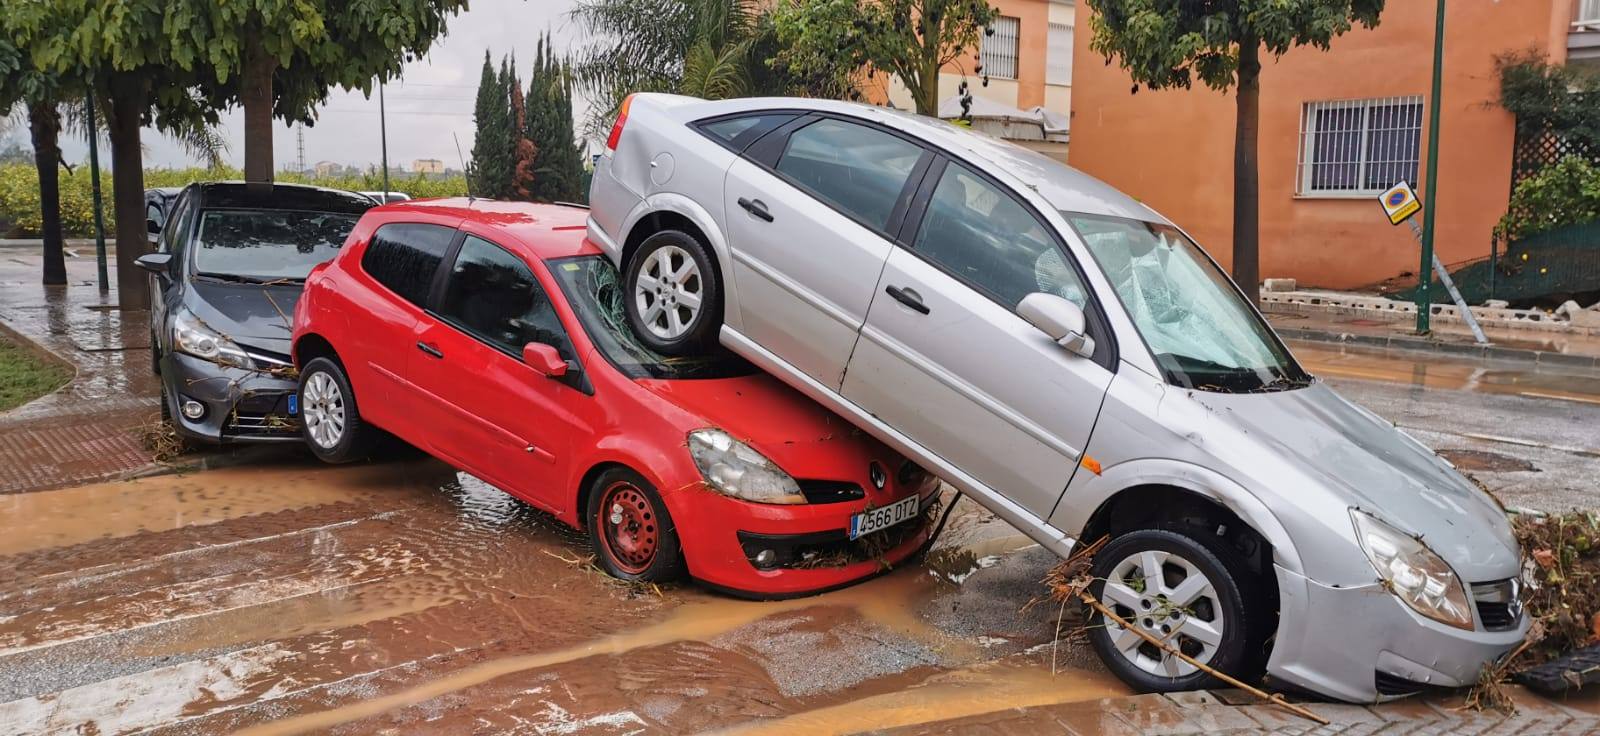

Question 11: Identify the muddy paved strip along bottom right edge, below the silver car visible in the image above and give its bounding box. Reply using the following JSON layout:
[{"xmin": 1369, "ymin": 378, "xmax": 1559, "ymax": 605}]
[{"xmin": 878, "ymin": 690, "xmax": 1600, "ymax": 736}]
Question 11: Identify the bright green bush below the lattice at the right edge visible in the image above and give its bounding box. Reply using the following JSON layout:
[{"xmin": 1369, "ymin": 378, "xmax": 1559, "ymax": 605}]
[{"xmin": 1494, "ymin": 155, "xmax": 1600, "ymax": 242}]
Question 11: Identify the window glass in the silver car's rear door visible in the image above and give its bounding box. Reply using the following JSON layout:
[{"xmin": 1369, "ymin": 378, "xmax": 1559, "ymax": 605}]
[{"xmin": 778, "ymin": 120, "xmax": 923, "ymax": 230}]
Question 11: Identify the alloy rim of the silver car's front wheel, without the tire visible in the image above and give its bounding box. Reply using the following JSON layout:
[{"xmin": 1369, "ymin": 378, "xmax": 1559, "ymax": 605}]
[{"xmin": 1101, "ymin": 550, "xmax": 1227, "ymax": 677}]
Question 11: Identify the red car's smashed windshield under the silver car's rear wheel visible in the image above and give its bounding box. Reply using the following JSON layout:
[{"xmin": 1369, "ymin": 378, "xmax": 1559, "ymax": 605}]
[{"xmin": 550, "ymin": 256, "xmax": 755, "ymax": 379}]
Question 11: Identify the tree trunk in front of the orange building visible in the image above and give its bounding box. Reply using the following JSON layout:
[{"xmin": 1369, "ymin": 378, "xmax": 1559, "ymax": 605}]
[{"xmin": 1234, "ymin": 35, "xmax": 1261, "ymax": 304}]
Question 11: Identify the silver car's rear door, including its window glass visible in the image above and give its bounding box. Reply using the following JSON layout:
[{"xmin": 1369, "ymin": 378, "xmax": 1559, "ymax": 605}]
[{"xmin": 723, "ymin": 117, "xmax": 931, "ymax": 389}]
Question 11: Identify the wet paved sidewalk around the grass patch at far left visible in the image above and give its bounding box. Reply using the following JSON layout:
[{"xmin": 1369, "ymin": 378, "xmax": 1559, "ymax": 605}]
[{"xmin": 0, "ymin": 250, "xmax": 160, "ymax": 494}]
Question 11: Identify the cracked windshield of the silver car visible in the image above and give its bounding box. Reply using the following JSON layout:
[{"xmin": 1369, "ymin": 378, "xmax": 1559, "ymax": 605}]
[{"xmin": 1062, "ymin": 213, "xmax": 1310, "ymax": 392}]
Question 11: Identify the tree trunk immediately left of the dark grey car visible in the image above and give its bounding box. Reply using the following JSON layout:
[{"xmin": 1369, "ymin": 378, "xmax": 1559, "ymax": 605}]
[{"xmin": 106, "ymin": 75, "xmax": 150, "ymax": 309}]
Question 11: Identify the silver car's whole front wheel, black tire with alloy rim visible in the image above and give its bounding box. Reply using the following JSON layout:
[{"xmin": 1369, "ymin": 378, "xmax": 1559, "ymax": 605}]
[{"xmin": 1088, "ymin": 530, "xmax": 1272, "ymax": 693}]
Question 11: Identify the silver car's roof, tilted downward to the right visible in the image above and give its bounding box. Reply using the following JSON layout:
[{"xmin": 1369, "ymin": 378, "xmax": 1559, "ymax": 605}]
[{"xmin": 650, "ymin": 94, "xmax": 1168, "ymax": 222}]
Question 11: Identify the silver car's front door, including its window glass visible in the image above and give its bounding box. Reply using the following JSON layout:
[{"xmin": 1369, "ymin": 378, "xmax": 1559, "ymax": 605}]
[{"xmin": 842, "ymin": 162, "xmax": 1115, "ymax": 518}]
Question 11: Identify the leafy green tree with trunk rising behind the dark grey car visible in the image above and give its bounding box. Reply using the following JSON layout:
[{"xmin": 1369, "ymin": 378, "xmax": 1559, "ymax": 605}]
[{"xmin": 168, "ymin": 0, "xmax": 467, "ymax": 189}]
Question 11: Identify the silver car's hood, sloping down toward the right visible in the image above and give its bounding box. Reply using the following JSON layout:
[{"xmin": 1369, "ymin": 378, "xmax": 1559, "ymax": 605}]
[{"xmin": 1189, "ymin": 382, "xmax": 1520, "ymax": 582}]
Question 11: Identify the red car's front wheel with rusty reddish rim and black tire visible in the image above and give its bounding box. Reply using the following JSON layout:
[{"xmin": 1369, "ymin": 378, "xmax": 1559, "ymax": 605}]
[{"xmin": 584, "ymin": 467, "xmax": 683, "ymax": 582}]
